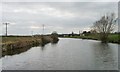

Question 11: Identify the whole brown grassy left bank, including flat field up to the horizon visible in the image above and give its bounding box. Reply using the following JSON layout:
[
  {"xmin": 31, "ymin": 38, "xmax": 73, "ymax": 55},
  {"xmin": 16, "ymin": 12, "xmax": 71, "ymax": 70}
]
[{"xmin": 0, "ymin": 36, "xmax": 58, "ymax": 52}]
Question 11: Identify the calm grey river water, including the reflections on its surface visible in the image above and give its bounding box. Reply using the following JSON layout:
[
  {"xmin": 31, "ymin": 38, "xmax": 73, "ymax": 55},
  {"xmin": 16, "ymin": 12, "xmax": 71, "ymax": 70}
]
[{"xmin": 0, "ymin": 38, "xmax": 118, "ymax": 70}]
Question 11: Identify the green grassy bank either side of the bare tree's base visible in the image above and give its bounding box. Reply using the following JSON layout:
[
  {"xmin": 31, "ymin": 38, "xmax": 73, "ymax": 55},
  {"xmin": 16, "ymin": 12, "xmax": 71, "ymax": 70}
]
[{"xmin": 65, "ymin": 34, "xmax": 120, "ymax": 44}]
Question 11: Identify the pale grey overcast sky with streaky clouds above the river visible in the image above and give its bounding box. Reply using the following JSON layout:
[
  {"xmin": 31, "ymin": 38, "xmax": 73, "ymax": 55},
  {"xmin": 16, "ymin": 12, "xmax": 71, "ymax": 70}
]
[{"xmin": 2, "ymin": 2, "xmax": 118, "ymax": 35}]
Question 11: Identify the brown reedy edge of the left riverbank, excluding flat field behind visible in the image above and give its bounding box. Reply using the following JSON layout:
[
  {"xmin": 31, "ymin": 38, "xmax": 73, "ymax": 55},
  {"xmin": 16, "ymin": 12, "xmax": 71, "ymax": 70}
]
[{"xmin": 1, "ymin": 36, "xmax": 59, "ymax": 52}]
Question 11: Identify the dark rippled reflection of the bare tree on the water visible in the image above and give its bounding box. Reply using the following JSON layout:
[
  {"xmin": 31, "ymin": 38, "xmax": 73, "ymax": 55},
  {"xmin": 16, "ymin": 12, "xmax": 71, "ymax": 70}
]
[{"xmin": 93, "ymin": 42, "xmax": 118, "ymax": 69}]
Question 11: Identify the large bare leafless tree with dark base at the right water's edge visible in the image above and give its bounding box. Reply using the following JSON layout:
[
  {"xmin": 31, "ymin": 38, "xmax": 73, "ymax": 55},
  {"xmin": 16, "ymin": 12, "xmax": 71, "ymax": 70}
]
[{"xmin": 92, "ymin": 13, "xmax": 116, "ymax": 42}]
